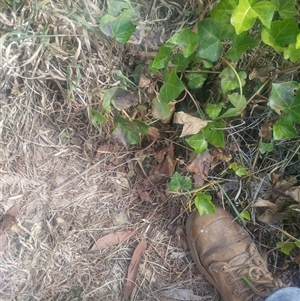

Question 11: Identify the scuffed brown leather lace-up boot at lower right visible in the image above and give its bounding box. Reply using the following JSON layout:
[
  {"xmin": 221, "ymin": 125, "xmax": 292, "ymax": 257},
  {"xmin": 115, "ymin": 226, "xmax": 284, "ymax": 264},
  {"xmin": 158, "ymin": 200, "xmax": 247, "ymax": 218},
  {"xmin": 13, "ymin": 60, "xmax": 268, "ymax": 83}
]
[{"xmin": 187, "ymin": 208, "xmax": 282, "ymax": 301}]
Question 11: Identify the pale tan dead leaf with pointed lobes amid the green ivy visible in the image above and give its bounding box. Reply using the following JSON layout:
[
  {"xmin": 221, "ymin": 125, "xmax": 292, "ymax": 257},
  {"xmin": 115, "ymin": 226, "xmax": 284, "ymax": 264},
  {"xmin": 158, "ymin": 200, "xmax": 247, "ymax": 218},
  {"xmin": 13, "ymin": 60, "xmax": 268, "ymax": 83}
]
[{"xmin": 173, "ymin": 112, "xmax": 208, "ymax": 137}]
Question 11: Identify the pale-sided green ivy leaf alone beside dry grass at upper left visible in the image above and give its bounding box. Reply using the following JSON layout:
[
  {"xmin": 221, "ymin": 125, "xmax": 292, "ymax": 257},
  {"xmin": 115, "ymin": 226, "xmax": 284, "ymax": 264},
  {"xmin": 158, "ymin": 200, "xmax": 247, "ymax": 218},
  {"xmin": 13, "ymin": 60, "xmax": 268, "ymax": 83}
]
[{"xmin": 100, "ymin": 9, "xmax": 136, "ymax": 43}]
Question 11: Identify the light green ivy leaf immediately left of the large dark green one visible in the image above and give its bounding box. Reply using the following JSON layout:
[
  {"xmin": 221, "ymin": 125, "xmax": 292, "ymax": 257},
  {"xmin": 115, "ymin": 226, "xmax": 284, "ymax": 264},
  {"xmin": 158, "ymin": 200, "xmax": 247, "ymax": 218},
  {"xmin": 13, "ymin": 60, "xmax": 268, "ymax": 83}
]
[{"xmin": 169, "ymin": 28, "xmax": 199, "ymax": 58}]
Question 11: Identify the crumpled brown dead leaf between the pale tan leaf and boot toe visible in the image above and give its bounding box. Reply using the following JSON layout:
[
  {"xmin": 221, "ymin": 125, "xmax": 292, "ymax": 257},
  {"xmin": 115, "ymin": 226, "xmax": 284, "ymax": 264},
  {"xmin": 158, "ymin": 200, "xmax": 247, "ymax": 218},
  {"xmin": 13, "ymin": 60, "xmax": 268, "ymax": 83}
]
[{"xmin": 187, "ymin": 150, "xmax": 212, "ymax": 187}]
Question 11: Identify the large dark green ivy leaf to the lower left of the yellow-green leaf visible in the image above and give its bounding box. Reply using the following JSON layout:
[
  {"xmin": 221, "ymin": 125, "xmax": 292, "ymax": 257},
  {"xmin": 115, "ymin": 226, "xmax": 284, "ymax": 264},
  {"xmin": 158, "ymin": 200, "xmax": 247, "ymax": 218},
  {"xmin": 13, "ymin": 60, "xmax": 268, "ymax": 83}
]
[{"xmin": 197, "ymin": 18, "xmax": 234, "ymax": 62}]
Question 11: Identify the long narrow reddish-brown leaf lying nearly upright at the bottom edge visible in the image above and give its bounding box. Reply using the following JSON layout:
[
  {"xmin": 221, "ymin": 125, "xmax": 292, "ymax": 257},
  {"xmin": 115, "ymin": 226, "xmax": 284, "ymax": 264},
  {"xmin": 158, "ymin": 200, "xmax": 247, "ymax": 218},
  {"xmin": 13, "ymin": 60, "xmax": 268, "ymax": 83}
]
[{"xmin": 123, "ymin": 237, "xmax": 147, "ymax": 298}]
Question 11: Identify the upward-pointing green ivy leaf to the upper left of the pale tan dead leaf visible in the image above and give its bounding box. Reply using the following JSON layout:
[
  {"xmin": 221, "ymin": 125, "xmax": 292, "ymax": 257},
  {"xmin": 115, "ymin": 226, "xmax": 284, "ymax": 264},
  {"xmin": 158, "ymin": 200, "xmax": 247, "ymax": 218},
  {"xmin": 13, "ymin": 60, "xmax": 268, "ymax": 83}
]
[{"xmin": 160, "ymin": 68, "xmax": 185, "ymax": 102}]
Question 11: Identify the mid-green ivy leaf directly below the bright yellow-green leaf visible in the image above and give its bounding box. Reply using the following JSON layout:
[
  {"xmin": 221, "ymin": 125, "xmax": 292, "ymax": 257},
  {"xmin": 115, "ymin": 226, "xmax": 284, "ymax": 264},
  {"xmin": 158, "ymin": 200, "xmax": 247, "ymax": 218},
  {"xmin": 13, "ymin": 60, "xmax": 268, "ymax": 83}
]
[{"xmin": 227, "ymin": 32, "xmax": 259, "ymax": 62}]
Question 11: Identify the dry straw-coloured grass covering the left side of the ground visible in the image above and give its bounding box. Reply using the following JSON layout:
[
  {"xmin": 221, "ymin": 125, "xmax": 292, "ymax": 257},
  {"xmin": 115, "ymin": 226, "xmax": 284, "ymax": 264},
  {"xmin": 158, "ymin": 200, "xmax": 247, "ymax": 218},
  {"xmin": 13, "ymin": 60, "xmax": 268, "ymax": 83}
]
[{"xmin": 0, "ymin": 0, "xmax": 217, "ymax": 301}]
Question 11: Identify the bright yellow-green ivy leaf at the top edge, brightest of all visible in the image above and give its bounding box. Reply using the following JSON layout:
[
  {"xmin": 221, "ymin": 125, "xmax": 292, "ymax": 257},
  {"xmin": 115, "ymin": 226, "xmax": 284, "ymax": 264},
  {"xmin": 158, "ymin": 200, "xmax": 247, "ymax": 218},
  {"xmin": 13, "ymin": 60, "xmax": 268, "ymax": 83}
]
[{"xmin": 231, "ymin": 0, "xmax": 276, "ymax": 34}]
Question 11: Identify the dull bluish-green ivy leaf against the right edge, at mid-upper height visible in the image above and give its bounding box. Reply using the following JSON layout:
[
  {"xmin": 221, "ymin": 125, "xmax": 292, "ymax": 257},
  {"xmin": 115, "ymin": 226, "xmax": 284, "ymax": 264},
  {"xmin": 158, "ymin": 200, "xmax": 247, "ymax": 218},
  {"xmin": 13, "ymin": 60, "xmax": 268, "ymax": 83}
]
[{"xmin": 268, "ymin": 81, "xmax": 300, "ymax": 115}]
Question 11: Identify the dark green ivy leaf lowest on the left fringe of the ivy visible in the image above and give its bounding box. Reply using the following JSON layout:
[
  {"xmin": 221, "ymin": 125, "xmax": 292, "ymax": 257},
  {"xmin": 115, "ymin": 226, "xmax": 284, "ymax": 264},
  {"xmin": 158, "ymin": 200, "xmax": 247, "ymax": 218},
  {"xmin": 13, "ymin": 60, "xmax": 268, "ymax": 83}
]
[{"xmin": 114, "ymin": 115, "xmax": 141, "ymax": 144}]
